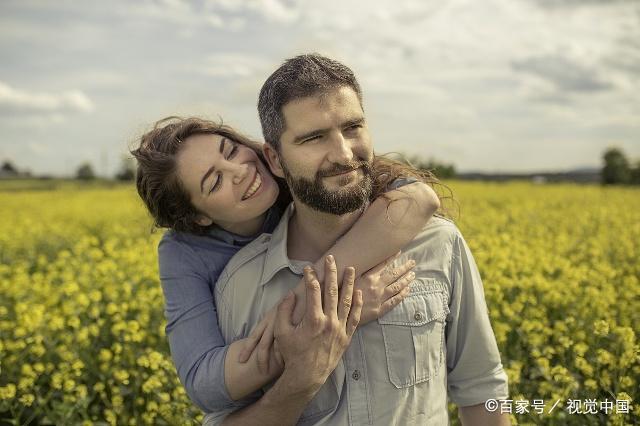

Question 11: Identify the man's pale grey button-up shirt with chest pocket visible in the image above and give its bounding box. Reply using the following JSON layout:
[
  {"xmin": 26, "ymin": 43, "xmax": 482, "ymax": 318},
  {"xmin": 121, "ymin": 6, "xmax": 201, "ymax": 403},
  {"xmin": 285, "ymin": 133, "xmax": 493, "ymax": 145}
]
[{"xmin": 210, "ymin": 205, "xmax": 508, "ymax": 426}]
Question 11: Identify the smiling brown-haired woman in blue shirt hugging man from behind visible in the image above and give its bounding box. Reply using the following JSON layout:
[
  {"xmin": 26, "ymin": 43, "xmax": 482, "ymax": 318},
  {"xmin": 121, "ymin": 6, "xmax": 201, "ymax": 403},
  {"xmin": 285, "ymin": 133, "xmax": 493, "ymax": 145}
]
[{"xmin": 132, "ymin": 117, "xmax": 439, "ymax": 411}]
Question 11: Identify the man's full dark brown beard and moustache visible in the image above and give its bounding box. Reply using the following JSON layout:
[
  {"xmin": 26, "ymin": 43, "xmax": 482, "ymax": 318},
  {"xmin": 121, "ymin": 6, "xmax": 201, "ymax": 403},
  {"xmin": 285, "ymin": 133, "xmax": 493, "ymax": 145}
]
[{"xmin": 281, "ymin": 161, "xmax": 373, "ymax": 216}]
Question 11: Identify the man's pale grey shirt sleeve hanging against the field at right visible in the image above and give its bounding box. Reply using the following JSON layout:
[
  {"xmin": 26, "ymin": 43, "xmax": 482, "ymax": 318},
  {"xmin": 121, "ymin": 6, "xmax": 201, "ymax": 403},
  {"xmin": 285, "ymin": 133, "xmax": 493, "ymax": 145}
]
[{"xmin": 447, "ymin": 235, "xmax": 509, "ymax": 407}]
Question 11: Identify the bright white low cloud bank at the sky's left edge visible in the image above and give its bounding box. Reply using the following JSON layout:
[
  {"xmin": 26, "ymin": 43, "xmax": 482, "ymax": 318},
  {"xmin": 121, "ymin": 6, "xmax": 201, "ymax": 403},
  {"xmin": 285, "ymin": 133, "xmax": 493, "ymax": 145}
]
[{"xmin": 0, "ymin": 82, "xmax": 95, "ymax": 114}]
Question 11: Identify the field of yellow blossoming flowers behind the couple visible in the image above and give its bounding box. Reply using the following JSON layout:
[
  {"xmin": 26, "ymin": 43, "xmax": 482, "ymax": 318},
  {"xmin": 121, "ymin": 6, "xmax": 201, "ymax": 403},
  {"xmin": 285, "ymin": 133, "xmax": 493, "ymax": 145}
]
[{"xmin": 0, "ymin": 182, "xmax": 640, "ymax": 425}]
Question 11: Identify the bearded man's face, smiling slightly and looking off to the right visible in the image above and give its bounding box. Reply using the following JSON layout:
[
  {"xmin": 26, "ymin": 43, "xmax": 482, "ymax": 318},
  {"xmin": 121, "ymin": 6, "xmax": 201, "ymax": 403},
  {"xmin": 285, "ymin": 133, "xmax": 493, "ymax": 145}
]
[{"xmin": 273, "ymin": 86, "xmax": 373, "ymax": 215}]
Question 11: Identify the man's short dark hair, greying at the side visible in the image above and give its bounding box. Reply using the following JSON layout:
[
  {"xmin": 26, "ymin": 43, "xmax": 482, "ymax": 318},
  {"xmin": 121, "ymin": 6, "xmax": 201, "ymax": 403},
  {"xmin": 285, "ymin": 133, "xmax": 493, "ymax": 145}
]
[{"xmin": 258, "ymin": 53, "xmax": 362, "ymax": 151}]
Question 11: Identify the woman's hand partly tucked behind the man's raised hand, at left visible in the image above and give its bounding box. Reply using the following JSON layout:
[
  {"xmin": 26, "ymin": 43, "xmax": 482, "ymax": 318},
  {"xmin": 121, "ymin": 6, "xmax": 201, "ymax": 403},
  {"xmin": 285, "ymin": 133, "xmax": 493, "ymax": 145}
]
[{"xmin": 238, "ymin": 305, "xmax": 284, "ymax": 376}]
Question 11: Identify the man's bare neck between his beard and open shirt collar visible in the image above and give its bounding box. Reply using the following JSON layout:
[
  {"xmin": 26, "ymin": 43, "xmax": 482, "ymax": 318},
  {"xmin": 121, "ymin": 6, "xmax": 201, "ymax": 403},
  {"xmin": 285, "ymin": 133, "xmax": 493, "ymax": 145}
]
[{"xmin": 287, "ymin": 200, "xmax": 363, "ymax": 262}]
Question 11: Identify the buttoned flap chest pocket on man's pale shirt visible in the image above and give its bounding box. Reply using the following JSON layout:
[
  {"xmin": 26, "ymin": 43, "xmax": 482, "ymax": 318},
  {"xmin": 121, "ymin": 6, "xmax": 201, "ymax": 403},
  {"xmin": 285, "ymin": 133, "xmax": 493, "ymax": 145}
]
[{"xmin": 378, "ymin": 278, "xmax": 449, "ymax": 388}]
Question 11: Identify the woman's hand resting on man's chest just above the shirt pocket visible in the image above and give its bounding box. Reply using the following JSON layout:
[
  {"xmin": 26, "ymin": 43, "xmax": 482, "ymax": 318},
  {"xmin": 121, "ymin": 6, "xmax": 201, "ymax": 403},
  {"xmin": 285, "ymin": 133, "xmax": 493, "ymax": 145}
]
[{"xmin": 355, "ymin": 253, "xmax": 416, "ymax": 325}]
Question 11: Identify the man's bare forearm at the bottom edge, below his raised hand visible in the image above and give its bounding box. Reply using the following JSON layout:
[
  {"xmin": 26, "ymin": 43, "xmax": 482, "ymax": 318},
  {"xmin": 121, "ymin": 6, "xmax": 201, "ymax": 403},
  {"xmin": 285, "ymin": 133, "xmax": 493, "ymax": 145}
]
[{"xmin": 222, "ymin": 368, "xmax": 320, "ymax": 426}]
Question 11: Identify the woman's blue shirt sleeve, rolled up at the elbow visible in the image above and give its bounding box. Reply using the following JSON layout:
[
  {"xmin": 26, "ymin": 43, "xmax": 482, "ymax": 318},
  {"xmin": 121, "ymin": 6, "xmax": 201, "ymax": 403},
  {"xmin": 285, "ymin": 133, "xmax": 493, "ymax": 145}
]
[{"xmin": 158, "ymin": 238, "xmax": 234, "ymax": 412}]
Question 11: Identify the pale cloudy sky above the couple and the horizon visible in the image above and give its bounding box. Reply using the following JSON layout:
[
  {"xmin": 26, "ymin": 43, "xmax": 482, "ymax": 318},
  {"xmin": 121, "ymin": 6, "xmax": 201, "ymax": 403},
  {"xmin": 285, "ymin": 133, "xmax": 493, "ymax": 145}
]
[{"xmin": 0, "ymin": 0, "xmax": 640, "ymax": 175}]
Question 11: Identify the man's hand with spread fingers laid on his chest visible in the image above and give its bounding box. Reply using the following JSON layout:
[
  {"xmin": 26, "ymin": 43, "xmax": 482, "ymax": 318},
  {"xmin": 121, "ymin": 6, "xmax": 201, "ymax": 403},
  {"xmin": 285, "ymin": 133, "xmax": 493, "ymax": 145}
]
[{"xmin": 275, "ymin": 255, "xmax": 362, "ymax": 396}]
